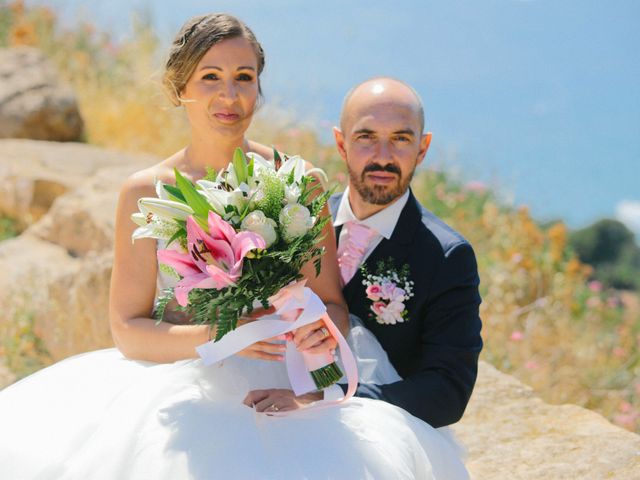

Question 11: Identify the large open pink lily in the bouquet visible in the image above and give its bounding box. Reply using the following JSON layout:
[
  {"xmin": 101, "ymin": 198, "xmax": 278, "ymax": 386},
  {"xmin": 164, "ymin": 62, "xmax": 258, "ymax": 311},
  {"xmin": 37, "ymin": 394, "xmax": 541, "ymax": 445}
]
[{"xmin": 158, "ymin": 211, "xmax": 266, "ymax": 307}]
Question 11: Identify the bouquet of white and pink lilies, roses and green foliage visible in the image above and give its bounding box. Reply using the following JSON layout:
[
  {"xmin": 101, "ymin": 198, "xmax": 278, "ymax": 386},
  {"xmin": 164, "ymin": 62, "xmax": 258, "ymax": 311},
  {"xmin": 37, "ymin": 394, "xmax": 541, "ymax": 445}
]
[{"xmin": 132, "ymin": 148, "xmax": 342, "ymax": 388}]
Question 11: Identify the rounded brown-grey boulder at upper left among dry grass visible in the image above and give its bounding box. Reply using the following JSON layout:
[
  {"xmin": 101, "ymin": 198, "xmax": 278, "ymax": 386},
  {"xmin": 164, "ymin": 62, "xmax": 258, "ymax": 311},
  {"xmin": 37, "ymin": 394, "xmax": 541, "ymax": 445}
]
[{"xmin": 0, "ymin": 47, "xmax": 83, "ymax": 141}]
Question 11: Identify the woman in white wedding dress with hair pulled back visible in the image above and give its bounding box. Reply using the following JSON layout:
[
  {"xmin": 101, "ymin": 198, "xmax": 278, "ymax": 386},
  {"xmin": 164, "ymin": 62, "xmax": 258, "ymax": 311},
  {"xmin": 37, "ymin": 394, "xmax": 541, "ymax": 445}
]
[{"xmin": 0, "ymin": 14, "xmax": 468, "ymax": 480}]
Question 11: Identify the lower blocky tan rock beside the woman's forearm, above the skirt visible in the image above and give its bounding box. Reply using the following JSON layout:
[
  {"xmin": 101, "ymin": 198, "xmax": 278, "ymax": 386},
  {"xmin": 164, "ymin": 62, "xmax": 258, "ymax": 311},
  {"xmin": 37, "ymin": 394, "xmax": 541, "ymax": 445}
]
[{"xmin": 0, "ymin": 233, "xmax": 113, "ymax": 361}]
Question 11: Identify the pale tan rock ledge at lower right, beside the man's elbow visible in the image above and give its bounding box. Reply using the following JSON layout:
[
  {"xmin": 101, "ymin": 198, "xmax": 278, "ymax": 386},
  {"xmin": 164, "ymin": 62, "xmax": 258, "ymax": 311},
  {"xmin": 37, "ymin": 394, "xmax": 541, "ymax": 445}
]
[{"xmin": 453, "ymin": 362, "xmax": 640, "ymax": 480}]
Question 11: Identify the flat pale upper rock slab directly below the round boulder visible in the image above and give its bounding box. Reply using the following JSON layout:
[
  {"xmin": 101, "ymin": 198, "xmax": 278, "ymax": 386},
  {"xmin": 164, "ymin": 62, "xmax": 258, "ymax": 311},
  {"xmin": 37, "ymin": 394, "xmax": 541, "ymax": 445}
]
[{"xmin": 0, "ymin": 140, "xmax": 158, "ymax": 229}]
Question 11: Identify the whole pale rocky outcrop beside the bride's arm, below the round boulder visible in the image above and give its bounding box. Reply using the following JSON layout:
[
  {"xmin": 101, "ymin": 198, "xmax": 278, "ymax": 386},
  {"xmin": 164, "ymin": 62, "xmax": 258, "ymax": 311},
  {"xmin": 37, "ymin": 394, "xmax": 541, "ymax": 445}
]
[{"xmin": 0, "ymin": 140, "xmax": 158, "ymax": 360}]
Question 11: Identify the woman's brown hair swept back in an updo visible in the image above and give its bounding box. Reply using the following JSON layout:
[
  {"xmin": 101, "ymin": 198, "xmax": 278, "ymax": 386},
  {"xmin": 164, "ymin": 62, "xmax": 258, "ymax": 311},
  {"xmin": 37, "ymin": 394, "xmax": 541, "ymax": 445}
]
[{"xmin": 162, "ymin": 13, "xmax": 264, "ymax": 106}]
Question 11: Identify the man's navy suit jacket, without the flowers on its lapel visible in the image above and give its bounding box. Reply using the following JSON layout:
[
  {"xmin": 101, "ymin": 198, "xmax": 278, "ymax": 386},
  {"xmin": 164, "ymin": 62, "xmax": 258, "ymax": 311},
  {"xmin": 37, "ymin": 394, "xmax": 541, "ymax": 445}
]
[{"xmin": 329, "ymin": 189, "xmax": 482, "ymax": 427}]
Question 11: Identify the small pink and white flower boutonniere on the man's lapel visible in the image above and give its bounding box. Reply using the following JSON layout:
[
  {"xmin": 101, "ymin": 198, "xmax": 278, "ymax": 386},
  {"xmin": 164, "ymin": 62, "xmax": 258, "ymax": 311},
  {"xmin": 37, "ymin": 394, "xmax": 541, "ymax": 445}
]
[{"xmin": 360, "ymin": 259, "xmax": 413, "ymax": 325}]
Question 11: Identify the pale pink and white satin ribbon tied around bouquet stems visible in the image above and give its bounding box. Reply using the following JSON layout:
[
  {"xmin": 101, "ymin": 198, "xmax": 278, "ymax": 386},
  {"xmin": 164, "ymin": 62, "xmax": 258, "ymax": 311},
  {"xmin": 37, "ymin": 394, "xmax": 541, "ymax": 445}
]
[{"xmin": 196, "ymin": 281, "xmax": 358, "ymax": 416}]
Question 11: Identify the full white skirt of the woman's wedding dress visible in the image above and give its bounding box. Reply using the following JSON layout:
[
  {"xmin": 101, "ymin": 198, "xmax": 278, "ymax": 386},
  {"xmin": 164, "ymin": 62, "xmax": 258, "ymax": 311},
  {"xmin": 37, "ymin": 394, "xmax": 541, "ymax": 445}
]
[{"xmin": 0, "ymin": 268, "xmax": 468, "ymax": 480}]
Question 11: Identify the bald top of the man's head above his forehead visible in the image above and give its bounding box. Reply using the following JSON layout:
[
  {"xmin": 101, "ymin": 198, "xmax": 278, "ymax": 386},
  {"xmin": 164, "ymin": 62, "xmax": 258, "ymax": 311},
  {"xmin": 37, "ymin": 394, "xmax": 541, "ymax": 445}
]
[{"xmin": 340, "ymin": 77, "xmax": 424, "ymax": 134}]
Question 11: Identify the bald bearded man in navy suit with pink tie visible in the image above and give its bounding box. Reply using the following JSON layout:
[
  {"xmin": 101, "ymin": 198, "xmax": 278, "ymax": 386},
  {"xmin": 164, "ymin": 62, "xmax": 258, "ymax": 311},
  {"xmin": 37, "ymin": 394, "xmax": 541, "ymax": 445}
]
[{"xmin": 329, "ymin": 78, "xmax": 482, "ymax": 427}]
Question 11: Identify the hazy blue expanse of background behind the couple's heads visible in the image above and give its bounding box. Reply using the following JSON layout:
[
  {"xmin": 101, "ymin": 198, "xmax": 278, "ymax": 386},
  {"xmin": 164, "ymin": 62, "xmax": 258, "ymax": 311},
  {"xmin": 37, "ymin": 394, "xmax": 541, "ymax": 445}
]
[{"xmin": 41, "ymin": 0, "xmax": 640, "ymax": 234}]
